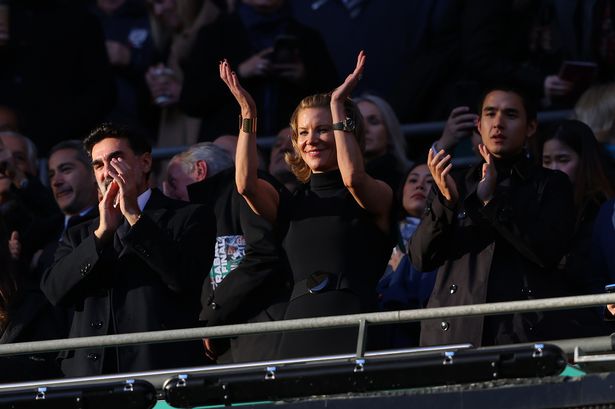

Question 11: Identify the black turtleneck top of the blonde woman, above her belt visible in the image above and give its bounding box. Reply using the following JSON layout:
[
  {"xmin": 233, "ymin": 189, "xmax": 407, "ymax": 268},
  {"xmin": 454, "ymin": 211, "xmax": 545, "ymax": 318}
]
[{"xmin": 284, "ymin": 170, "xmax": 392, "ymax": 302}]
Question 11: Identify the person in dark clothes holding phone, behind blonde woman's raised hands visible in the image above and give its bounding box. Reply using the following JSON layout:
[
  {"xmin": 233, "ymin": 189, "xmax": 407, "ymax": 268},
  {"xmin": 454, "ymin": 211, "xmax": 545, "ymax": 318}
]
[{"xmin": 180, "ymin": 0, "xmax": 338, "ymax": 141}]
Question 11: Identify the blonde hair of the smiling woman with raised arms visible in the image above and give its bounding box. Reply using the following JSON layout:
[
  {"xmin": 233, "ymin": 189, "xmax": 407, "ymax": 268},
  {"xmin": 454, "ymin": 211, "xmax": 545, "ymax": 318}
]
[{"xmin": 284, "ymin": 94, "xmax": 365, "ymax": 183}]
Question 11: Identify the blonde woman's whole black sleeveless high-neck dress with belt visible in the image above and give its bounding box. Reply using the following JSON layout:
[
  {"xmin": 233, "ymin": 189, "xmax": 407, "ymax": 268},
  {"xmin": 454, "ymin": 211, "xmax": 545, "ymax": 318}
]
[{"xmin": 279, "ymin": 170, "xmax": 394, "ymax": 358}]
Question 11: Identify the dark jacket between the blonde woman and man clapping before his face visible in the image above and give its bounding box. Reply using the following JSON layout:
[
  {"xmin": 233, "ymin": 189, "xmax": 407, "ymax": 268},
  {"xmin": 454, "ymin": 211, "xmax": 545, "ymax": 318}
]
[{"xmin": 188, "ymin": 168, "xmax": 291, "ymax": 363}]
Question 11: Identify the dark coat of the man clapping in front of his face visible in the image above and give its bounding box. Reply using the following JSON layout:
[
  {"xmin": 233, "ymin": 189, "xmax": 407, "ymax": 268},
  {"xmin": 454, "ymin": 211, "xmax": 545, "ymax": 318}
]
[{"xmin": 41, "ymin": 189, "xmax": 216, "ymax": 376}]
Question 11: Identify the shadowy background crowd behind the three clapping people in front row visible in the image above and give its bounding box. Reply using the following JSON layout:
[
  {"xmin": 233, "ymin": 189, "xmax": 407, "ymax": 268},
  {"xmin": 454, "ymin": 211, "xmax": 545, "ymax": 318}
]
[{"xmin": 0, "ymin": 0, "xmax": 615, "ymax": 382}]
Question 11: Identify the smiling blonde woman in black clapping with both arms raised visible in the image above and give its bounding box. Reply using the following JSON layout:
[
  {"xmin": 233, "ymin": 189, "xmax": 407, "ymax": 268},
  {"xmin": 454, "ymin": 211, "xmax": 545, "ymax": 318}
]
[{"xmin": 220, "ymin": 52, "xmax": 395, "ymax": 358}]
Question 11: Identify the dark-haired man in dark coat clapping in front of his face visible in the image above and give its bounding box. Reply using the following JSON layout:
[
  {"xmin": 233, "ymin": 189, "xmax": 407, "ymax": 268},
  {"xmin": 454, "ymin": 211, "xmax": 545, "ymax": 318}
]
[{"xmin": 41, "ymin": 124, "xmax": 216, "ymax": 376}]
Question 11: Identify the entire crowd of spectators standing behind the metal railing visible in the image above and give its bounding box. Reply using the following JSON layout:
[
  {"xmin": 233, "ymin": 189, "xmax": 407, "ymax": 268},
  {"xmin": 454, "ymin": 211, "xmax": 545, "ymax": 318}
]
[{"xmin": 0, "ymin": 0, "xmax": 615, "ymax": 382}]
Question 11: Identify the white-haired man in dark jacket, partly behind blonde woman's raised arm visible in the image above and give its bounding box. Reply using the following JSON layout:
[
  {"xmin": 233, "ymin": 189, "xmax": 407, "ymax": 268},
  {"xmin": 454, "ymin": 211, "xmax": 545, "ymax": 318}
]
[{"xmin": 164, "ymin": 142, "xmax": 289, "ymax": 362}]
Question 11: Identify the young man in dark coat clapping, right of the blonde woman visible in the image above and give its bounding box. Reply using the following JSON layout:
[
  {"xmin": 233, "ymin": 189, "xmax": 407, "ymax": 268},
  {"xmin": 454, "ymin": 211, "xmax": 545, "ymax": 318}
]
[{"xmin": 409, "ymin": 88, "xmax": 574, "ymax": 346}]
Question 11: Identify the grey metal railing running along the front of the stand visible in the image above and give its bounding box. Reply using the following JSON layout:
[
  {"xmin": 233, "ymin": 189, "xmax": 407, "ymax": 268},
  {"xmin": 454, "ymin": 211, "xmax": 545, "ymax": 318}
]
[{"xmin": 0, "ymin": 294, "xmax": 615, "ymax": 399}]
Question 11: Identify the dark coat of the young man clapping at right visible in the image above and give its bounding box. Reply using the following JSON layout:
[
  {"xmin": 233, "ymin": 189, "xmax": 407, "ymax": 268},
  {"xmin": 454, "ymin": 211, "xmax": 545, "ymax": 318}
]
[{"xmin": 408, "ymin": 158, "xmax": 574, "ymax": 346}]
